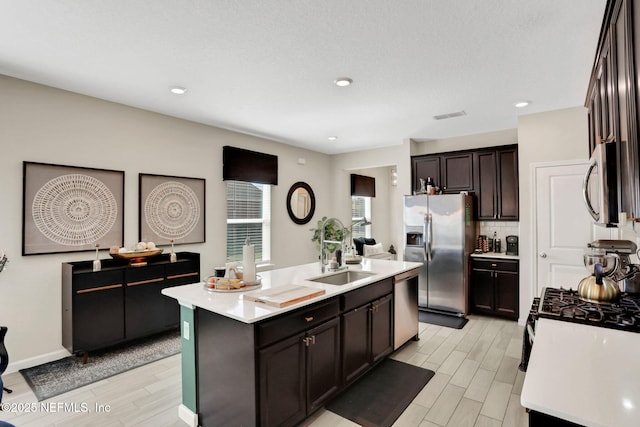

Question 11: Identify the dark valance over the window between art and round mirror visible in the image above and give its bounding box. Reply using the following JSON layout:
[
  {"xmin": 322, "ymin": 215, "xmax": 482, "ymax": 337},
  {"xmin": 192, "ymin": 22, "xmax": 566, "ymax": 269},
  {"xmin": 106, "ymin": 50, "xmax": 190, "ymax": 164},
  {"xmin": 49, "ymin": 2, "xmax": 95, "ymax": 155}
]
[{"xmin": 222, "ymin": 145, "xmax": 278, "ymax": 185}]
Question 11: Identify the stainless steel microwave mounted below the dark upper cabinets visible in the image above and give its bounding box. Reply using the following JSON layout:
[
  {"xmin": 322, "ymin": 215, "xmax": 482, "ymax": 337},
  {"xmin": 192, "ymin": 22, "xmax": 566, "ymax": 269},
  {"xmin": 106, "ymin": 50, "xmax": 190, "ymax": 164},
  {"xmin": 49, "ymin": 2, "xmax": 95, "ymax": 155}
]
[{"xmin": 582, "ymin": 141, "xmax": 619, "ymax": 226}]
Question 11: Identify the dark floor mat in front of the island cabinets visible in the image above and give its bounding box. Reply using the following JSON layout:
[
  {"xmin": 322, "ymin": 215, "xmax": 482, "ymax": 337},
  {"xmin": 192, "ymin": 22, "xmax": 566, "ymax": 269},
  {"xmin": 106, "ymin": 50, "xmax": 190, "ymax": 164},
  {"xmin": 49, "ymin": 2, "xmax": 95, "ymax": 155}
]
[{"xmin": 326, "ymin": 359, "xmax": 435, "ymax": 427}]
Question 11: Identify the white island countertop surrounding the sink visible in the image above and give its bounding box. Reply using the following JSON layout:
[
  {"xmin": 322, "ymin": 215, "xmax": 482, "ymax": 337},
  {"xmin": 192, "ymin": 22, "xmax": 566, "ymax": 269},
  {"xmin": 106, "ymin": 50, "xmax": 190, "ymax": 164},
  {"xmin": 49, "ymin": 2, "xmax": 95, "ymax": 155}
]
[{"xmin": 162, "ymin": 258, "xmax": 422, "ymax": 323}]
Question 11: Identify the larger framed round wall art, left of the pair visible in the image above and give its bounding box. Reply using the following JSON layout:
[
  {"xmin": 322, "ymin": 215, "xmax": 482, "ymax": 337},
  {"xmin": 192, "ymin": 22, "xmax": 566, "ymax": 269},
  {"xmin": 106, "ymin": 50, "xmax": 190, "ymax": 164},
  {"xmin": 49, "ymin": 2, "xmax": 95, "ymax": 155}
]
[{"xmin": 22, "ymin": 162, "xmax": 124, "ymax": 255}]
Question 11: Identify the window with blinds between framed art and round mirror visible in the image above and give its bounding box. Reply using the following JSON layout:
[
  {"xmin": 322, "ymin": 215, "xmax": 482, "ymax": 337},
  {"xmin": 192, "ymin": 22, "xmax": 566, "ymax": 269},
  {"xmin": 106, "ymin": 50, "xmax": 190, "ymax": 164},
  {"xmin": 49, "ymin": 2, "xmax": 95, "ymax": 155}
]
[{"xmin": 226, "ymin": 181, "xmax": 271, "ymax": 264}]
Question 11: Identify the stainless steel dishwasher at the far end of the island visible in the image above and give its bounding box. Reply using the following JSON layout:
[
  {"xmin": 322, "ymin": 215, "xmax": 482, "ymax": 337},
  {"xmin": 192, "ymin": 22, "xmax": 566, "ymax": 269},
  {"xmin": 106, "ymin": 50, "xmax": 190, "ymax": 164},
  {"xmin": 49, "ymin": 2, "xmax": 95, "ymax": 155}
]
[{"xmin": 393, "ymin": 270, "xmax": 419, "ymax": 350}]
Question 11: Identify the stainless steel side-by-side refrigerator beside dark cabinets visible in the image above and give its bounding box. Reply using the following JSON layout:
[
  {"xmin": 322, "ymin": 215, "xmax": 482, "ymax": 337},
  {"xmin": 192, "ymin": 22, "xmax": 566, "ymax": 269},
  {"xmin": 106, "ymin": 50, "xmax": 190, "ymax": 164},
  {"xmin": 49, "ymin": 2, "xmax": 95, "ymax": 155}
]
[{"xmin": 404, "ymin": 194, "xmax": 477, "ymax": 316}]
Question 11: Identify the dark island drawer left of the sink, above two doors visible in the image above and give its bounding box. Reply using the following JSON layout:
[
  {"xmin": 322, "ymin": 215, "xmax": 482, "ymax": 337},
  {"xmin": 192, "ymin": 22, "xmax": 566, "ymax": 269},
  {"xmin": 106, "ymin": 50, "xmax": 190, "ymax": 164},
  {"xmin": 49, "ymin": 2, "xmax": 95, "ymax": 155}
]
[{"xmin": 257, "ymin": 298, "xmax": 339, "ymax": 347}]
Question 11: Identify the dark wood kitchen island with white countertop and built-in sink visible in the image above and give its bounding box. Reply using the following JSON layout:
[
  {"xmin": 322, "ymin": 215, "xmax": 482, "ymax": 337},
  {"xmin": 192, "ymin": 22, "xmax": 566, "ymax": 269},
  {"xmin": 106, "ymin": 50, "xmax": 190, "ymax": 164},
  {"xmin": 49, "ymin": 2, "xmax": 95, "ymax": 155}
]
[{"xmin": 163, "ymin": 259, "xmax": 421, "ymax": 426}]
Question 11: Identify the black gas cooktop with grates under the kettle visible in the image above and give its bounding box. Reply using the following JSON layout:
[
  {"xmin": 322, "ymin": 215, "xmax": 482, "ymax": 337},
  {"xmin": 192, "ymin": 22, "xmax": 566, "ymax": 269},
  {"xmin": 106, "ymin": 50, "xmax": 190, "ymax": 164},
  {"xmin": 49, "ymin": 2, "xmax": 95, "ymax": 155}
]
[{"xmin": 530, "ymin": 288, "xmax": 640, "ymax": 332}]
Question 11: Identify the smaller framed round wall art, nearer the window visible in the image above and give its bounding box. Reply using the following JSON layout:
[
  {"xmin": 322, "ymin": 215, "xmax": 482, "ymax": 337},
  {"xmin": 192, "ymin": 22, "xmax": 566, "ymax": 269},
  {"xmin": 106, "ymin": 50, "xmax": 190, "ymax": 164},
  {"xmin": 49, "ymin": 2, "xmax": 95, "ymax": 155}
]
[{"xmin": 139, "ymin": 174, "xmax": 205, "ymax": 245}]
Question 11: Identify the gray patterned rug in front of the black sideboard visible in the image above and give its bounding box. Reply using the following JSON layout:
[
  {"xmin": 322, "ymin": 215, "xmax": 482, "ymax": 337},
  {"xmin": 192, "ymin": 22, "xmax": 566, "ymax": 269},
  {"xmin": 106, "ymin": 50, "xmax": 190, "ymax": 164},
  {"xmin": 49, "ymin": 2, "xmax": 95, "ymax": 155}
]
[{"xmin": 20, "ymin": 330, "xmax": 180, "ymax": 401}]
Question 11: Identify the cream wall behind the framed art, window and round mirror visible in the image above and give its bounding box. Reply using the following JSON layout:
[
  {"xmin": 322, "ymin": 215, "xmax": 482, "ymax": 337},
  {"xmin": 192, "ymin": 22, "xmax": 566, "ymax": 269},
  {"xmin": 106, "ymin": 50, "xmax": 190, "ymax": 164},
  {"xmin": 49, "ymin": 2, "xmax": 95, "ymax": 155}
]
[{"xmin": 0, "ymin": 76, "xmax": 334, "ymax": 370}]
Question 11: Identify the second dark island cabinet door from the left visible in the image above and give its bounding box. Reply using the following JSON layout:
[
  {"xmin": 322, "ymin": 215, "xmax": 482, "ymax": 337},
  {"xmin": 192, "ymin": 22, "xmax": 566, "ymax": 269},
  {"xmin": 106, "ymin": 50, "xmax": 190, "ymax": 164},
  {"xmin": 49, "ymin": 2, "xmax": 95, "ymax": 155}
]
[{"xmin": 305, "ymin": 318, "xmax": 341, "ymax": 413}]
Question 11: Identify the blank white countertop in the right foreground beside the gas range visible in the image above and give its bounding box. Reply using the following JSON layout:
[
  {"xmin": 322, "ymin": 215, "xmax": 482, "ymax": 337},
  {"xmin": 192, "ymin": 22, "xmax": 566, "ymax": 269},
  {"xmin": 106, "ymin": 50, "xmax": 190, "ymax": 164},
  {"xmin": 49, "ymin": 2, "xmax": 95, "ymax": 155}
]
[{"xmin": 520, "ymin": 319, "xmax": 640, "ymax": 427}]
